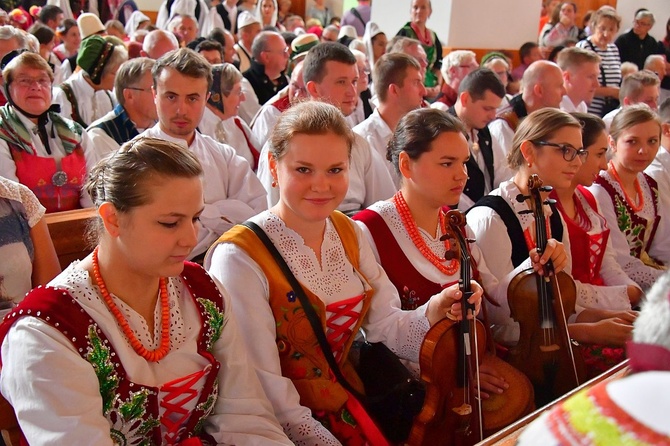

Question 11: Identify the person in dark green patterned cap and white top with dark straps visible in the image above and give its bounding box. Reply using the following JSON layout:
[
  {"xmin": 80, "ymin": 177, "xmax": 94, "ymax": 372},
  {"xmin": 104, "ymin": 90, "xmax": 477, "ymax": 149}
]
[{"xmin": 54, "ymin": 35, "xmax": 128, "ymax": 128}]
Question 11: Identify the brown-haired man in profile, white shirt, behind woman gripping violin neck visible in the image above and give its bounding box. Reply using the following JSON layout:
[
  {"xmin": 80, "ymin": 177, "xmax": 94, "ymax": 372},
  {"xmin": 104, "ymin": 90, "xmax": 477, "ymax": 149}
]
[{"xmin": 354, "ymin": 53, "xmax": 426, "ymax": 187}]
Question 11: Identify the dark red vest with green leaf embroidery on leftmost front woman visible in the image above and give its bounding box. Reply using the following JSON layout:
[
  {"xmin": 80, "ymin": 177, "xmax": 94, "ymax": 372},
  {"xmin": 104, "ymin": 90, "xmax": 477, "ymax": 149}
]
[{"xmin": 0, "ymin": 262, "xmax": 224, "ymax": 446}]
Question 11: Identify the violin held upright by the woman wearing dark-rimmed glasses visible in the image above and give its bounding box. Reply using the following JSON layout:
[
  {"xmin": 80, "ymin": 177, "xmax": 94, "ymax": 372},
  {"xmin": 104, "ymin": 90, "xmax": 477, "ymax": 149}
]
[{"xmin": 507, "ymin": 175, "xmax": 586, "ymax": 407}]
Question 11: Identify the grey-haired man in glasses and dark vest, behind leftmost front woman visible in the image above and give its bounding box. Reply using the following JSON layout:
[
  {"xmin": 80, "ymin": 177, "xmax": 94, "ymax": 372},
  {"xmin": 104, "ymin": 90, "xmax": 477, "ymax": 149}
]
[{"xmin": 86, "ymin": 57, "xmax": 158, "ymax": 156}]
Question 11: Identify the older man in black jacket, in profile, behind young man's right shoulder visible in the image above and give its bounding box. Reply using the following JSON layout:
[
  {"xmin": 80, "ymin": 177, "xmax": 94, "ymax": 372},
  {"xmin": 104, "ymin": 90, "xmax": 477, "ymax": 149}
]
[{"xmin": 243, "ymin": 31, "xmax": 289, "ymax": 105}]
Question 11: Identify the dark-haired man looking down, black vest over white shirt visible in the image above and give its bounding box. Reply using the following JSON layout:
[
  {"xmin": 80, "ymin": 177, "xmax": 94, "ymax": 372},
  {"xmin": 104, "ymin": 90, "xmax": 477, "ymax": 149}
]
[{"xmin": 449, "ymin": 68, "xmax": 513, "ymax": 212}]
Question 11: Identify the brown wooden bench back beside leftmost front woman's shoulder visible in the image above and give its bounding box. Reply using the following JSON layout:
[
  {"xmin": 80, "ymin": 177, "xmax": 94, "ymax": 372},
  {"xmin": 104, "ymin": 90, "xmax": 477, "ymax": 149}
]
[{"xmin": 44, "ymin": 208, "xmax": 97, "ymax": 269}]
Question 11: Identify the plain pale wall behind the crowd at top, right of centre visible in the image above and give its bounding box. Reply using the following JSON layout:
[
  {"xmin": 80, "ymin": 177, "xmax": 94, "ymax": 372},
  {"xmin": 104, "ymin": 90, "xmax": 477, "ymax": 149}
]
[{"xmin": 372, "ymin": 0, "xmax": 544, "ymax": 49}]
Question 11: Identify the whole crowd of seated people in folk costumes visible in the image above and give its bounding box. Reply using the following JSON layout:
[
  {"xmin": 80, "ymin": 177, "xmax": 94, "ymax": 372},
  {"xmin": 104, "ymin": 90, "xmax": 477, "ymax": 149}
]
[{"xmin": 0, "ymin": 0, "xmax": 670, "ymax": 446}]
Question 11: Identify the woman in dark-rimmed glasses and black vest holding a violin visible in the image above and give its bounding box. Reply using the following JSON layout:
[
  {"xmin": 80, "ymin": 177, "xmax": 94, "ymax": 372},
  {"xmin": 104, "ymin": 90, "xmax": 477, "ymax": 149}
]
[{"xmin": 467, "ymin": 109, "xmax": 630, "ymax": 352}]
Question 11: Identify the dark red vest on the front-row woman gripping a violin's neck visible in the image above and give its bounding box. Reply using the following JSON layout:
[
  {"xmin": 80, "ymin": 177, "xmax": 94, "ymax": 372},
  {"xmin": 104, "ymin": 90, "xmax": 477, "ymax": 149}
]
[{"xmin": 354, "ymin": 209, "xmax": 458, "ymax": 310}]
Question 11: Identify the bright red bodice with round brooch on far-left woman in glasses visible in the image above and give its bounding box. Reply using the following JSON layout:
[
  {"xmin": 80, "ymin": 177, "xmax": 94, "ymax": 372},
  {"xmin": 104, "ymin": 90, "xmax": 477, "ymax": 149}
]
[{"xmin": 9, "ymin": 144, "xmax": 86, "ymax": 212}]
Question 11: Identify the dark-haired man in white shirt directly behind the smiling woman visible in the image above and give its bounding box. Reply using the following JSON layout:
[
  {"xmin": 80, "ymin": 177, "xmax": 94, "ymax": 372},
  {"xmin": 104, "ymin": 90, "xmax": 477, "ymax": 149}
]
[{"xmin": 258, "ymin": 42, "xmax": 396, "ymax": 214}]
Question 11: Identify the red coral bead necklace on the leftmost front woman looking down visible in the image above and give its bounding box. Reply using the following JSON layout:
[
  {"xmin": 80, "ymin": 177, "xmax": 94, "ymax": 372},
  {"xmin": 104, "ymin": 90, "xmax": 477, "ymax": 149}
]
[{"xmin": 93, "ymin": 247, "xmax": 170, "ymax": 362}]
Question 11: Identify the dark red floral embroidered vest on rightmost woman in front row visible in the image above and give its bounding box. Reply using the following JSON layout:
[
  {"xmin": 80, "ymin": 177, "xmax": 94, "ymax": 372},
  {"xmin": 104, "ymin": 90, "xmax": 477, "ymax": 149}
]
[{"xmin": 596, "ymin": 173, "xmax": 663, "ymax": 265}]
